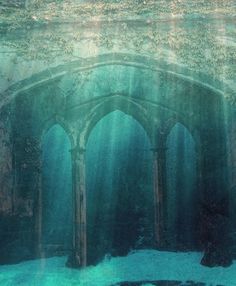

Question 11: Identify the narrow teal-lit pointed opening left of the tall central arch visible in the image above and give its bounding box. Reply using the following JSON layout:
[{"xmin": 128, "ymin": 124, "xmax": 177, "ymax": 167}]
[{"xmin": 42, "ymin": 124, "xmax": 73, "ymax": 256}]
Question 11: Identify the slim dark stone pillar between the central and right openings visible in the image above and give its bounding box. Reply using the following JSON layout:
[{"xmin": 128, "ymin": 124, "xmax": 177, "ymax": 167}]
[{"xmin": 152, "ymin": 141, "xmax": 166, "ymax": 248}]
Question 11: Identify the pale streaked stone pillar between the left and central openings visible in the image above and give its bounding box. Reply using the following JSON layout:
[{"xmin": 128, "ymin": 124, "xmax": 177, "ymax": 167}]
[{"xmin": 67, "ymin": 146, "xmax": 87, "ymax": 268}]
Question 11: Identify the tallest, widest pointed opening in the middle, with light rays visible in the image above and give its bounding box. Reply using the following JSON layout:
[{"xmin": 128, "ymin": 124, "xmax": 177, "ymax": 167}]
[{"xmin": 86, "ymin": 111, "xmax": 154, "ymax": 264}]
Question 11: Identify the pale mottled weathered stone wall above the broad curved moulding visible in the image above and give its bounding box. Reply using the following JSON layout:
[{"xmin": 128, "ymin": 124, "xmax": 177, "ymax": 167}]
[{"xmin": 0, "ymin": 0, "xmax": 236, "ymax": 103}]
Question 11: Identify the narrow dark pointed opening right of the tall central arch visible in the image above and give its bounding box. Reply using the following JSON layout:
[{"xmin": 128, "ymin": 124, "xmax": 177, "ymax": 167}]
[{"xmin": 166, "ymin": 123, "xmax": 199, "ymax": 250}]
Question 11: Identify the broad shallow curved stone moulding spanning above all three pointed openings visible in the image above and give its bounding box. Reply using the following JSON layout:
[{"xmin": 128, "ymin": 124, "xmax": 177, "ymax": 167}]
[{"xmin": 0, "ymin": 53, "xmax": 234, "ymax": 113}]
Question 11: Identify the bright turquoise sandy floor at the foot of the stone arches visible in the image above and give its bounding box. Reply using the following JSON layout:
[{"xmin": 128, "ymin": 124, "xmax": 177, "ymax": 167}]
[{"xmin": 0, "ymin": 250, "xmax": 236, "ymax": 286}]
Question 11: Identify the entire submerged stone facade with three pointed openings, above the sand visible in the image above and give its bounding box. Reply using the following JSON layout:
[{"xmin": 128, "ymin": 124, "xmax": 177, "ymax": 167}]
[{"xmin": 0, "ymin": 1, "xmax": 236, "ymax": 278}]
